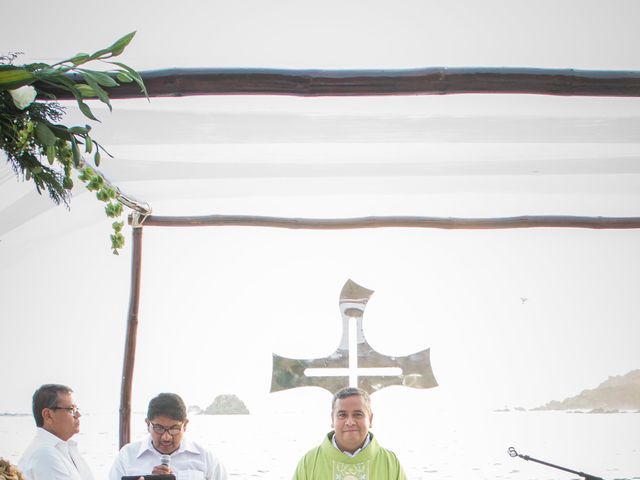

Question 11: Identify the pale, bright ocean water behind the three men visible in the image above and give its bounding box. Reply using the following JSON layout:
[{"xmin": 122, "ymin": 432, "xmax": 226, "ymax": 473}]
[{"xmin": 0, "ymin": 408, "xmax": 640, "ymax": 480}]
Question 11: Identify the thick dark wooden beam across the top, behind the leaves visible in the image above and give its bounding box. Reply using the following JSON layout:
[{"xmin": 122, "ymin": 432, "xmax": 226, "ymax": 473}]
[{"xmin": 38, "ymin": 67, "xmax": 640, "ymax": 100}]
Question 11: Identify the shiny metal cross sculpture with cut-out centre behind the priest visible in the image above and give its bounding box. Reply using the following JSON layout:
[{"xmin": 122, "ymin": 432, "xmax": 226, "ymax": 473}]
[{"xmin": 271, "ymin": 280, "xmax": 438, "ymax": 393}]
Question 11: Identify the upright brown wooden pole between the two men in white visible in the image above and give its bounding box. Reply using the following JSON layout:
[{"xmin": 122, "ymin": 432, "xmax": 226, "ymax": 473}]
[{"xmin": 120, "ymin": 223, "xmax": 142, "ymax": 448}]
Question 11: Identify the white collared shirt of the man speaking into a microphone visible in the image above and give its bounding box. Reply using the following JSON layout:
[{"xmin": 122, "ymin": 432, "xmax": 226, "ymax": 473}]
[{"xmin": 109, "ymin": 435, "xmax": 227, "ymax": 480}]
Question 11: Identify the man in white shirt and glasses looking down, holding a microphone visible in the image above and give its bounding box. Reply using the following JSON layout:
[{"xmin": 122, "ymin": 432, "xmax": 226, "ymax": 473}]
[{"xmin": 109, "ymin": 393, "xmax": 227, "ymax": 480}]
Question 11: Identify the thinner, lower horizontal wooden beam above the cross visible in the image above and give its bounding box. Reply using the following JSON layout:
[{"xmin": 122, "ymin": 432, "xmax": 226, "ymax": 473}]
[{"xmin": 134, "ymin": 215, "xmax": 640, "ymax": 230}]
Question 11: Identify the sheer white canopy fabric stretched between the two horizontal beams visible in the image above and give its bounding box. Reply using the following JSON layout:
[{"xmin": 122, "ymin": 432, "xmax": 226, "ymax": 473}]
[{"xmin": 0, "ymin": 90, "xmax": 640, "ymax": 249}]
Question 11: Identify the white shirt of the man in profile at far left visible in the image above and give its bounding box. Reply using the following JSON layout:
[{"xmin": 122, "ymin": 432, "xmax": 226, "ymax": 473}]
[{"xmin": 18, "ymin": 427, "xmax": 93, "ymax": 480}]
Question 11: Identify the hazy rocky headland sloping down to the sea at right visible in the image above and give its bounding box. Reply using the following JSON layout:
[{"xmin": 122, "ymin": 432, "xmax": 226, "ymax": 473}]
[{"xmin": 533, "ymin": 370, "xmax": 640, "ymax": 413}]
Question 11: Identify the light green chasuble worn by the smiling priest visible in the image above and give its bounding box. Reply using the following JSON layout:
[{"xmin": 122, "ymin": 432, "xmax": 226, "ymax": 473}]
[{"xmin": 293, "ymin": 432, "xmax": 407, "ymax": 480}]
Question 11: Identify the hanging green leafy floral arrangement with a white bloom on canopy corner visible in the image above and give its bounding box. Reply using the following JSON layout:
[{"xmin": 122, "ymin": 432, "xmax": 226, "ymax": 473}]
[{"xmin": 0, "ymin": 32, "xmax": 147, "ymax": 254}]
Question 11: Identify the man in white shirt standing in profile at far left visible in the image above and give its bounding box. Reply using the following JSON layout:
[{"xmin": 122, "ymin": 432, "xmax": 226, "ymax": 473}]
[{"xmin": 18, "ymin": 384, "xmax": 93, "ymax": 480}]
